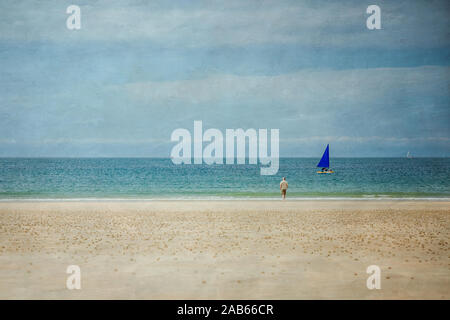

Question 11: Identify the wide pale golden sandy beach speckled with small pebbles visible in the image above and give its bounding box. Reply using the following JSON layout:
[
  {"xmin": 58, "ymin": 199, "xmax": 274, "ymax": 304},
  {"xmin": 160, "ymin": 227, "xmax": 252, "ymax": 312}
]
[{"xmin": 0, "ymin": 201, "xmax": 450, "ymax": 299}]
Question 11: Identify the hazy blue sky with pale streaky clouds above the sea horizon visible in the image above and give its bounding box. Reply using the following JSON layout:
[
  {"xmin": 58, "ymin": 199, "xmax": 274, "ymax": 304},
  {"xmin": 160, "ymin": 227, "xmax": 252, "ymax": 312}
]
[{"xmin": 0, "ymin": 0, "xmax": 450, "ymax": 157}]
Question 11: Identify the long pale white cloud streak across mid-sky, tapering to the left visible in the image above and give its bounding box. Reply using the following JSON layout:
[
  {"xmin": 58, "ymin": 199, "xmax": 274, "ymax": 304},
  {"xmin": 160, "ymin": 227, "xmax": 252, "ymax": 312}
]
[{"xmin": 121, "ymin": 66, "xmax": 450, "ymax": 106}]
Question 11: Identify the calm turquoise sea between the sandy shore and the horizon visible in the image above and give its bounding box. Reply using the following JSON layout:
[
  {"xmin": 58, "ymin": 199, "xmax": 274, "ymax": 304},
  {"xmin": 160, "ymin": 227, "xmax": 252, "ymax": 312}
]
[{"xmin": 0, "ymin": 158, "xmax": 450, "ymax": 200}]
